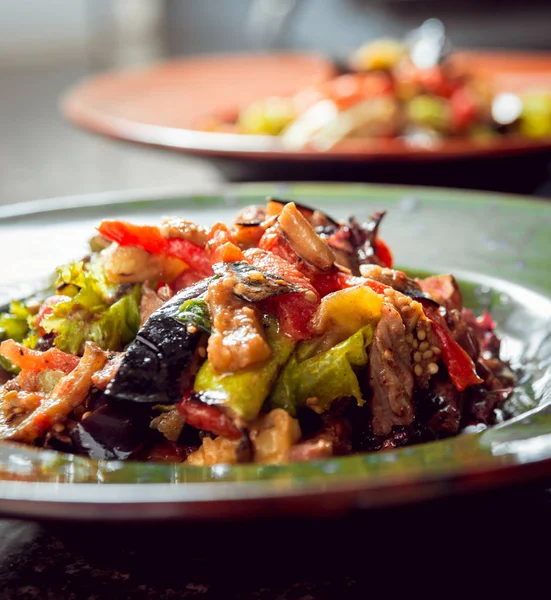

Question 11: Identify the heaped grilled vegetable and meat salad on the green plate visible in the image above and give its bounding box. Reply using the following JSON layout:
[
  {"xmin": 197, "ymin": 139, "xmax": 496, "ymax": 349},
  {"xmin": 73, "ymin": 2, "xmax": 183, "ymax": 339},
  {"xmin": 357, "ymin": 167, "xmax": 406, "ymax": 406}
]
[{"xmin": 0, "ymin": 199, "xmax": 515, "ymax": 466}]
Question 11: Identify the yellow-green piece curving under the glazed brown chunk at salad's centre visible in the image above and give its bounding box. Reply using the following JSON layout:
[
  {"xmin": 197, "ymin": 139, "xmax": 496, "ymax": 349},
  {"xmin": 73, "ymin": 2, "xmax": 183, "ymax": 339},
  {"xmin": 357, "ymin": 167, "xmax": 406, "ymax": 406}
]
[{"xmin": 194, "ymin": 320, "xmax": 295, "ymax": 421}]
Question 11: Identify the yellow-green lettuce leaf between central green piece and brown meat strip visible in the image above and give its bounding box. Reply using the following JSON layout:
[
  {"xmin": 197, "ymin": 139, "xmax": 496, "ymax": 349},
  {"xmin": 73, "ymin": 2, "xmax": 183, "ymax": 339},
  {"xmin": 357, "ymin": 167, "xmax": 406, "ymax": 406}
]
[{"xmin": 270, "ymin": 325, "xmax": 373, "ymax": 415}]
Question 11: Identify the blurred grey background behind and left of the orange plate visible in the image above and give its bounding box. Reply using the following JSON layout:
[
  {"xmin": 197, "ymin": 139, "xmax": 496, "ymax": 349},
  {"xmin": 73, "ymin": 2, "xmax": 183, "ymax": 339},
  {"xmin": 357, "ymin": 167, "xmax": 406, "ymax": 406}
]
[{"xmin": 0, "ymin": 0, "xmax": 551, "ymax": 202}]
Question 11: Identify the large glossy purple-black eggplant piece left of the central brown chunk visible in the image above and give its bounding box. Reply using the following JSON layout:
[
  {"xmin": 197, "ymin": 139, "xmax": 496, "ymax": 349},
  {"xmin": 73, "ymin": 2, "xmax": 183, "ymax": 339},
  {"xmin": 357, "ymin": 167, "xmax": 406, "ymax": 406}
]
[{"xmin": 105, "ymin": 278, "xmax": 211, "ymax": 405}]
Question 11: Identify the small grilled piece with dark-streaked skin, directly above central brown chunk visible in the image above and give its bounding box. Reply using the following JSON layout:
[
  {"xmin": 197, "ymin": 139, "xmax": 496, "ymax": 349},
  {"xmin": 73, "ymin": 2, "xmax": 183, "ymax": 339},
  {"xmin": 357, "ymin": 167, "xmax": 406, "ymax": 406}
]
[{"xmin": 213, "ymin": 261, "xmax": 307, "ymax": 302}]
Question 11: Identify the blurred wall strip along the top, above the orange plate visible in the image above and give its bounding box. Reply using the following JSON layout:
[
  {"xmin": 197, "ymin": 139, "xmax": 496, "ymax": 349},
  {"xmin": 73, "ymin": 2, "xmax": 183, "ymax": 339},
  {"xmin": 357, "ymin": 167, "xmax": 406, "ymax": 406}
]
[{"xmin": 4, "ymin": 0, "xmax": 551, "ymax": 65}]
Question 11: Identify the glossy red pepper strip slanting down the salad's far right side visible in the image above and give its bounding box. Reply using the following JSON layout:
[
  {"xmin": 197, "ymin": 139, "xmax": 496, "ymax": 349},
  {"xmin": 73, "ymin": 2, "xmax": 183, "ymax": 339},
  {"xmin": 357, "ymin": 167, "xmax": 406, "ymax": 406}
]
[{"xmin": 423, "ymin": 306, "xmax": 483, "ymax": 392}]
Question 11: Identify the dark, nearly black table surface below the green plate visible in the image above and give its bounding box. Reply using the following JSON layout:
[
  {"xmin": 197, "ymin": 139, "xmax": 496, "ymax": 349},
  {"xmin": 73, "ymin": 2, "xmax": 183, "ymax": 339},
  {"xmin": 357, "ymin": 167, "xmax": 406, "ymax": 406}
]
[{"xmin": 0, "ymin": 482, "xmax": 551, "ymax": 600}]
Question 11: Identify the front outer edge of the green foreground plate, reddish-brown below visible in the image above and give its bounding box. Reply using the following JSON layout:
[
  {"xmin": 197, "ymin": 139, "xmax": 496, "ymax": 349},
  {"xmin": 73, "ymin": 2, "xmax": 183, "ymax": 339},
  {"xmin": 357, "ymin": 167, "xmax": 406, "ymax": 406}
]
[{"xmin": 0, "ymin": 456, "xmax": 551, "ymax": 522}]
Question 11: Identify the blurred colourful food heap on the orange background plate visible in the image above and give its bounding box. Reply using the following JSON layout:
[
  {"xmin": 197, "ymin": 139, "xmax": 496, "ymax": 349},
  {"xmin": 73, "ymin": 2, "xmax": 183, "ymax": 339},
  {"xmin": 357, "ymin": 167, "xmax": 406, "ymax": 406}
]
[{"xmin": 201, "ymin": 19, "xmax": 551, "ymax": 151}]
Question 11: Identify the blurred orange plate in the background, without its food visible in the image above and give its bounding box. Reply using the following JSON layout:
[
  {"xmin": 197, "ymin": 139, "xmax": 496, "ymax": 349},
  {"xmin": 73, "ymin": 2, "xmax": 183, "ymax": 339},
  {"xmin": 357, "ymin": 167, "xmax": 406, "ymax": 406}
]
[{"xmin": 61, "ymin": 51, "xmax": 551, "ymax": 162}]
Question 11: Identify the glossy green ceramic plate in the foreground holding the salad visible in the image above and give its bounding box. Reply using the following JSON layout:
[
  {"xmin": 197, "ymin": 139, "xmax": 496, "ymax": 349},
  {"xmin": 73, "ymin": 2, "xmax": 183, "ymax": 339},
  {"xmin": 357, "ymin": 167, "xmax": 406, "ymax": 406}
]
[{"xmin": 0, "ymin": 184, "xmax": 551, "ymax": 520}]
